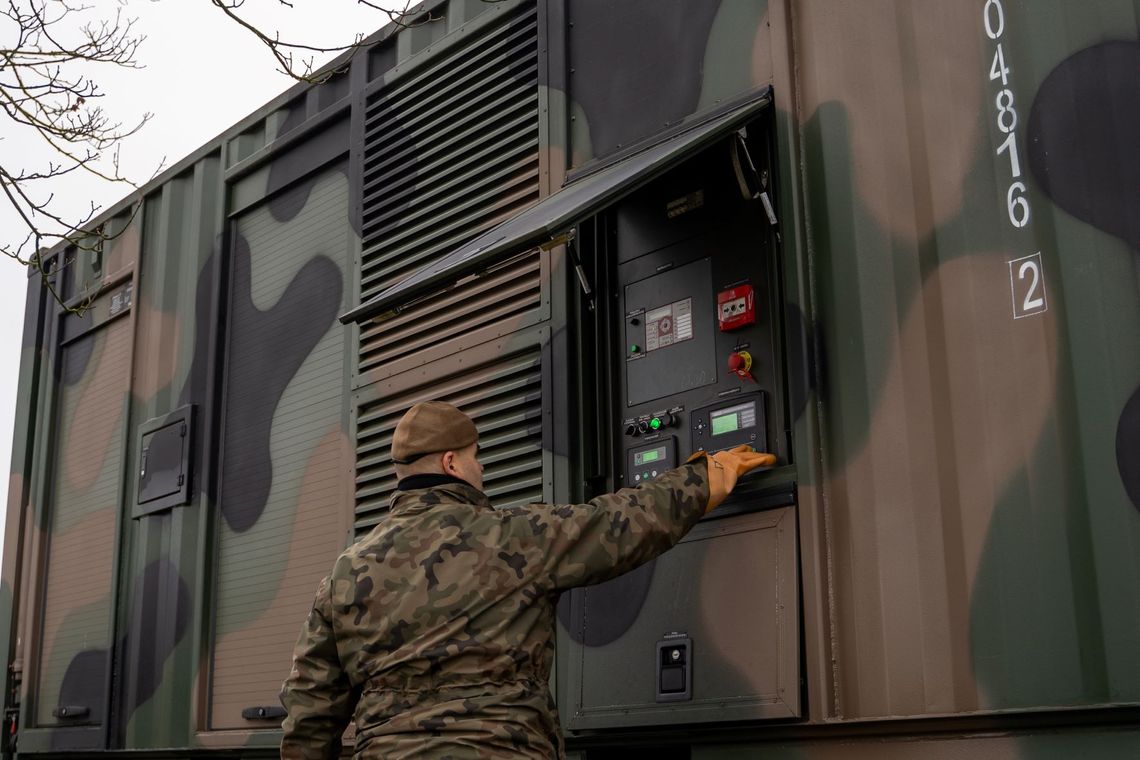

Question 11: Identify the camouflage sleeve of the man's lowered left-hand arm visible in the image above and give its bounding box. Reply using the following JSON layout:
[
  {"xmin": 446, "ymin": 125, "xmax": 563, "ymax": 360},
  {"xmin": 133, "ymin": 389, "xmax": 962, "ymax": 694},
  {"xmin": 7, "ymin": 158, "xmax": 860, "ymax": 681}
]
[{"xmin": 280, "ymin": 578, "xmax": 357, "ymax": 760}]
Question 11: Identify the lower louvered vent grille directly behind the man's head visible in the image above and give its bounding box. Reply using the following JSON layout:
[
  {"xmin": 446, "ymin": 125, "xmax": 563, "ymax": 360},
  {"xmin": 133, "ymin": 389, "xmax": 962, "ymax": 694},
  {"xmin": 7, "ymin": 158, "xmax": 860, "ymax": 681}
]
[{"xmin": 356, "ymin": 346, "xmax": 543, "ymax": 534}]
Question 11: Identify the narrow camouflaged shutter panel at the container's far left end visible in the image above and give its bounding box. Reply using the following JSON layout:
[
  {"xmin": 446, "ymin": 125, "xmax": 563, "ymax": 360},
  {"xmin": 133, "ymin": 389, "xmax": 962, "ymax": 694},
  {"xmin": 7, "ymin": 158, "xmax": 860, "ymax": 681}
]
[{"xmin": 36, "ymin": 318, "xmax": 131, "ymax": 725}]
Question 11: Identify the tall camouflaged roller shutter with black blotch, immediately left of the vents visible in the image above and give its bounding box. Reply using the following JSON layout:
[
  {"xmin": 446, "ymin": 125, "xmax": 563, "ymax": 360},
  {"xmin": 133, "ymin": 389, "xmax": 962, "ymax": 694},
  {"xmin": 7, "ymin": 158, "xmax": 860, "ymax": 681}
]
[{"xmin": 210, "ymin": 171, "xmax": 351, "ymax": 729}]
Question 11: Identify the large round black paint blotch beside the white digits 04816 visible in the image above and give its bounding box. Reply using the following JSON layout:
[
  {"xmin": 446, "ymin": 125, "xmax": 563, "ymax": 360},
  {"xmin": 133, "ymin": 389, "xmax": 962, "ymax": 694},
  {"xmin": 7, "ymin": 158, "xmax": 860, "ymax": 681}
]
[{"xmin": 1026, "ymin": 41, "xmax": 1140, "ymax": 251}]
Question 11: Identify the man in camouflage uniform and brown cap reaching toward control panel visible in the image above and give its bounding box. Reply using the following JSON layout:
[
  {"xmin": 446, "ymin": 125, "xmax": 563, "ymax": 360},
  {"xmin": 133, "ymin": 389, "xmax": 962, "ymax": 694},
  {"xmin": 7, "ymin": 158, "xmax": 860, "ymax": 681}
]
[{"xmin": 282, "ymin": 401, "xmax": 775, "ymax": 759}]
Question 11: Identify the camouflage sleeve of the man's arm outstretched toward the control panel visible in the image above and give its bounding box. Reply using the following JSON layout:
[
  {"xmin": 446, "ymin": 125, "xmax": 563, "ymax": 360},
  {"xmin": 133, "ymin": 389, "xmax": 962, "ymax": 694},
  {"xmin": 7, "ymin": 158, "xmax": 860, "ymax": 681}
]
[{"xmin": 530, "ymin": 458, "xmax": 709, "ymax": 590}]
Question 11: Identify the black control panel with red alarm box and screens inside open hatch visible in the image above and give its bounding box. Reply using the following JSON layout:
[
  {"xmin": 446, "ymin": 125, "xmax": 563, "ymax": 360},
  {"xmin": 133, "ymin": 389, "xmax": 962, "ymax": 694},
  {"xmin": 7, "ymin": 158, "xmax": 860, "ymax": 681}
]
[{"xmin": 614, "ymin": 144, "xmax": 789, "ymax": 496}]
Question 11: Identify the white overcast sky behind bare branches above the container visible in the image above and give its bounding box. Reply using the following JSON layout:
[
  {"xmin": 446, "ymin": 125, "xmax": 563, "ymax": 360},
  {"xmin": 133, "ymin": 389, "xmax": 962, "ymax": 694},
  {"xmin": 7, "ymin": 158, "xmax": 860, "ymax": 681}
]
[{"xmin": 0, "ymin": 0, "xmax": 406, "ymax": 553}]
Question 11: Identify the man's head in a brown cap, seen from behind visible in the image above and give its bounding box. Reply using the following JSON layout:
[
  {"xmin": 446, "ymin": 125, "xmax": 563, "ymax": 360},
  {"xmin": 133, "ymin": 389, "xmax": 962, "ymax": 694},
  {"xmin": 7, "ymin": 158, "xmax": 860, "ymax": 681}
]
[{"xmin": 392, "ymin": 401, "xmax": 483, "ymax": 490}]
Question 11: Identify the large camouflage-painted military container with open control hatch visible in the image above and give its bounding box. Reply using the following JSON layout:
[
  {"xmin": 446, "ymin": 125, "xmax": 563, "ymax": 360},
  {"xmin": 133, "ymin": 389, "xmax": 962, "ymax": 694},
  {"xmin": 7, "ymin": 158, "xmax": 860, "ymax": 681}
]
[{"xmin": 0, "ymin": 0, "xmax": 1140, "ymax": 759}]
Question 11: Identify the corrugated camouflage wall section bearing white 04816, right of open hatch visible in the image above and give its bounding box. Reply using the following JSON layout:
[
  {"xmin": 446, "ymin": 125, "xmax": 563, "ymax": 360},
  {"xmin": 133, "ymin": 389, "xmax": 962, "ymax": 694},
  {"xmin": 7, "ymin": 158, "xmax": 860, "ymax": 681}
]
[{"xmin": 795, "ymin": 0, "xmax": 1140, "ymax": 718}]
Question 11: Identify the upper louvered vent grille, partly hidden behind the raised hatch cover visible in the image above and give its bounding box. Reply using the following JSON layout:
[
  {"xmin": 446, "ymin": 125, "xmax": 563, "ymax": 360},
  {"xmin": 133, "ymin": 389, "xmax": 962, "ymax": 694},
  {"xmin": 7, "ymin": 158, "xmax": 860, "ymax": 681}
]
[{"xmin": 360, "ymin": 6, "xmax": 539, "ymax": 371}]
